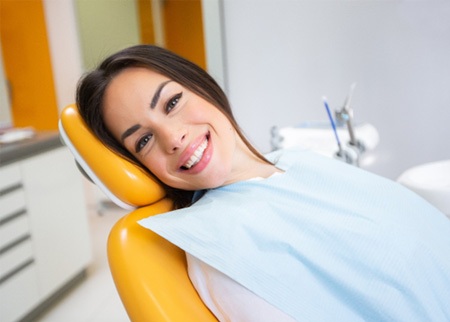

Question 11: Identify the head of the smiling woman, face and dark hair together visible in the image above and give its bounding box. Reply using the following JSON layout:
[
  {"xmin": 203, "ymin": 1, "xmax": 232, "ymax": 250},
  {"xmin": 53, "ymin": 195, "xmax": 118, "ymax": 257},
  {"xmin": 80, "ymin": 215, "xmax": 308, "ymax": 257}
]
[{"xmin": 77, "ymin": 45, "xmax": 273, "ymax": 206}]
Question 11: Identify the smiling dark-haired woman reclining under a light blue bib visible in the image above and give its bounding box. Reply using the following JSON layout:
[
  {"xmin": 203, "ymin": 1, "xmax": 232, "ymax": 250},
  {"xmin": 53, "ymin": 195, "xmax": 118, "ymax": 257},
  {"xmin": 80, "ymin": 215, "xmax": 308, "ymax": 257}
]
[{"xmin": 77, "ymin": 46, "xmax": 450, "ymax": 322}]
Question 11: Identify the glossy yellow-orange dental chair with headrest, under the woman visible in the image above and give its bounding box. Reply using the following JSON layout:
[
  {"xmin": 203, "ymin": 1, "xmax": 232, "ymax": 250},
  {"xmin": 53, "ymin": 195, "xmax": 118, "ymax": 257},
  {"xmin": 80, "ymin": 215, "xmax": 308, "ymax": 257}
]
[{"xmin": 59, "ymin": 105, "xmax": 217, "ymax": 322}]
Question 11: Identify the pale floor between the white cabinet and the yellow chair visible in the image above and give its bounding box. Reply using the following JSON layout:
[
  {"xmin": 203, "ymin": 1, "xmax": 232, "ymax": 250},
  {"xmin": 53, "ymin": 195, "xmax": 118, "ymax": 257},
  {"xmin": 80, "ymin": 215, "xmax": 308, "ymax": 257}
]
[{"xmin": 36, "ymin": 186, "xmax": 130, "ymax": 322}]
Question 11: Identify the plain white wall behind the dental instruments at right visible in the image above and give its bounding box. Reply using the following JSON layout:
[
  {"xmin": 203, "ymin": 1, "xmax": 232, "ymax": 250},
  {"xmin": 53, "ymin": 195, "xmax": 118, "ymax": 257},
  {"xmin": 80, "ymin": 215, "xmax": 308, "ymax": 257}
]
[{"xmin": 223, "ymin": 0, "xmax": 450, "ymax": 178}]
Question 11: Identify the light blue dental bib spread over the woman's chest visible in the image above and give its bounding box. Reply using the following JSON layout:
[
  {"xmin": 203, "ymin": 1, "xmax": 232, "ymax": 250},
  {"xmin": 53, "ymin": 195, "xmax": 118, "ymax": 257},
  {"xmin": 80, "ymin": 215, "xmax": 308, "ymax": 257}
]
[{"xmin": 139, "ymin": 151, "xmax": 450, "ymax": 322}]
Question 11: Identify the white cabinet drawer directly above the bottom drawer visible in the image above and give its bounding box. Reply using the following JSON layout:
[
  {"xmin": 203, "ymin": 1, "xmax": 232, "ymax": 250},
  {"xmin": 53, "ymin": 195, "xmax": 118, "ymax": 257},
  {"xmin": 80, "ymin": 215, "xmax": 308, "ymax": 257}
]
[{"xmin": 0, "ymin": 238, "xmax": 33, "ymax": 281}]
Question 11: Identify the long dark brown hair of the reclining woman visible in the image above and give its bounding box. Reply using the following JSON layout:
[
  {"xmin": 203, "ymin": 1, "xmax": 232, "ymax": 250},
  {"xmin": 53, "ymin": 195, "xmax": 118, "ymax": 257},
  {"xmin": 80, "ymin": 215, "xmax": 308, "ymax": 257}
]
[{"xmin": 76, "ymin": 45, "xmax": 267, "ymax": 208}]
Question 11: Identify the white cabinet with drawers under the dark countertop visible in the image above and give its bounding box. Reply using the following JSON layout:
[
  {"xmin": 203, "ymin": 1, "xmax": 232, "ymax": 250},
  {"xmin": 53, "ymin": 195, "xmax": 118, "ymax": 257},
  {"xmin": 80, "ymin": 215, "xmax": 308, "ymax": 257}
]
[{"xmin": 0, "ymin": 147, "xmax": 91, "ymax": 322}]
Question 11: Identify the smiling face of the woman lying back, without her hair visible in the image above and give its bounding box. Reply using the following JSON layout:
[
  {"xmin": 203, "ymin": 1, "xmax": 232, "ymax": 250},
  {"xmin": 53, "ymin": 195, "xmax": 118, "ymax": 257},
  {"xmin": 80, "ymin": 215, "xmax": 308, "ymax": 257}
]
[{"xmin": 103, "ymin": 67, "xmax": 247, "ymax": 190}]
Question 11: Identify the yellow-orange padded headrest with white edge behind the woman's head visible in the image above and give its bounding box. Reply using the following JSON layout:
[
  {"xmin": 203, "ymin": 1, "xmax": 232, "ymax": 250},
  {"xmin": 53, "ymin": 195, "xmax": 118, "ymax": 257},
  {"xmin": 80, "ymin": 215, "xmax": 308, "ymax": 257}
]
[{"xmin": 59, "ymin": 105, "xmax": 165, "ymax": 209}]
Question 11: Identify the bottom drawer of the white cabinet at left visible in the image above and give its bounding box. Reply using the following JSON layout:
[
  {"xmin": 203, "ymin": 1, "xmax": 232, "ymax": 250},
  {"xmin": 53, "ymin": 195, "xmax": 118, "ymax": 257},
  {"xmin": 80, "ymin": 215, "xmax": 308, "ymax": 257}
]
[{"xmin": 0, "ymin": 263, "xmax": 39, "ymax": 322}]
